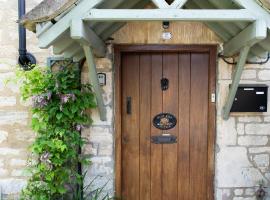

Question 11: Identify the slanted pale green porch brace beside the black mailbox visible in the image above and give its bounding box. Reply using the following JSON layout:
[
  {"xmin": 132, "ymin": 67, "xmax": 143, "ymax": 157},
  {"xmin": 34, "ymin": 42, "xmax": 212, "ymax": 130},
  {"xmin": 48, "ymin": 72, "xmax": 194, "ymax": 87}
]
[{"xmin": 223, "ymin": 46, "xmax": 250, "ymax": 120}]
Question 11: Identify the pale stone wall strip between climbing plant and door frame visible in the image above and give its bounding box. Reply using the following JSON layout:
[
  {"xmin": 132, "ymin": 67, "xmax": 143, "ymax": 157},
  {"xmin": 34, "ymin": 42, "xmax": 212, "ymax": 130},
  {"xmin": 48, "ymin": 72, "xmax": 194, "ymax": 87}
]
[{"xmin": 82, "ymin": 45, "xmax": 114, "ymax": 194}]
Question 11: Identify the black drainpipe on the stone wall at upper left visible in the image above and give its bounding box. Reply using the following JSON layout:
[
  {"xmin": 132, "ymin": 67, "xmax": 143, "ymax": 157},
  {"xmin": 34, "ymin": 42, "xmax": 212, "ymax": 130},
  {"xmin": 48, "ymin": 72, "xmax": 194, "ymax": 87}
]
[{"xmin": 18, "ymin": 0, "xmax": 36, "ymax": 71}]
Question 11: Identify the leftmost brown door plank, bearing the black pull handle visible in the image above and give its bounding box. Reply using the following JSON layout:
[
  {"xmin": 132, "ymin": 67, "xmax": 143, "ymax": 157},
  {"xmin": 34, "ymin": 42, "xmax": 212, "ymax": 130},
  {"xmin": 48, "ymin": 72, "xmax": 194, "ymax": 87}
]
[{"xmin": 122, "ymin": 54, "xmax": 140, "ymax": 200}]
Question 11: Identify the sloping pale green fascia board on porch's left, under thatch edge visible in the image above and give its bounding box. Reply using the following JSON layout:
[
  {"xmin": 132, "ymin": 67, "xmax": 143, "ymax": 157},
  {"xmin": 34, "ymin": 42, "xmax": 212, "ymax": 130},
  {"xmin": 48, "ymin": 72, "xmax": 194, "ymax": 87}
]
[{"xmin": 39, "ymin": 0, "xmax": 104, "ymax": 48}]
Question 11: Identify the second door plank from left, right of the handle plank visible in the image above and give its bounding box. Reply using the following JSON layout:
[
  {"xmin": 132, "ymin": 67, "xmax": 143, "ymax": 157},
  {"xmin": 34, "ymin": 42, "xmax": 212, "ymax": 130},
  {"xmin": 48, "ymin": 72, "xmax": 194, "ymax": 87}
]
[{"xmin": 139, "ymin": 53, "xmax": 152, "ymax": 200}]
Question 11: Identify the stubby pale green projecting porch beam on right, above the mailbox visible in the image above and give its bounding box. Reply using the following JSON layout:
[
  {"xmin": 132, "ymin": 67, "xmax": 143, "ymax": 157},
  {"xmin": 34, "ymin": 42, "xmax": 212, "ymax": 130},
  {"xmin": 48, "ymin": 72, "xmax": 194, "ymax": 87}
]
[{"xmin": 224, "ymin": 20, "xmax": 267, "ymax": 56}]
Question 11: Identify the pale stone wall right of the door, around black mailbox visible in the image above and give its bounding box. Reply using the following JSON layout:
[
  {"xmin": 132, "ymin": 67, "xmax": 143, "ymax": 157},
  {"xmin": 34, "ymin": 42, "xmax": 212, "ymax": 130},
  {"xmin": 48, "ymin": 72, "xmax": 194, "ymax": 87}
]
[{"xmin": 216, "ymin": 60, "xmax": 270, "ymax": 200}]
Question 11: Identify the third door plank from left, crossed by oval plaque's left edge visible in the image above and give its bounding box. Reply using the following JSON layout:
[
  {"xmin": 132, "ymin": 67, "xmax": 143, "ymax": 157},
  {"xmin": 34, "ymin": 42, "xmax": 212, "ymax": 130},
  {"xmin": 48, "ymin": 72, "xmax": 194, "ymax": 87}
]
[{"xmin": 150, "ymin": 53, "xmax": 162, "ymax": 200}]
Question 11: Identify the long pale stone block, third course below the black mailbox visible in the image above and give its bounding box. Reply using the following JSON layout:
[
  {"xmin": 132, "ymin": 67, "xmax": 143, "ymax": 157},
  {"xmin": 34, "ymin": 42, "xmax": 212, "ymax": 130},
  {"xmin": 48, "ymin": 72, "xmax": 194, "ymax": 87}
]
[{"xmin": 238, "ymin": 136, "xmax": 268, "ymax": 146}]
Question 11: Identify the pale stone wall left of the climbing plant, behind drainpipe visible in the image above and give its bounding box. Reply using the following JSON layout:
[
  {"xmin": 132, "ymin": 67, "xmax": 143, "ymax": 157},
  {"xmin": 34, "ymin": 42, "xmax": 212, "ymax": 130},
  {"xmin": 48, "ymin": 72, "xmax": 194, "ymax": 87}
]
[{"xmin": 0, "ymin": 0, "xmax": 49, "ymax": 199}]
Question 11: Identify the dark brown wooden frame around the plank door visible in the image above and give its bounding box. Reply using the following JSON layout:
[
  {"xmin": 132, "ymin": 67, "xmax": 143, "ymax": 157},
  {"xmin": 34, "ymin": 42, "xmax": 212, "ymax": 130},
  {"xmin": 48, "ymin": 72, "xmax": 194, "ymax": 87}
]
[{"xmin": 113, "ymin": 44, "xmax": 217, "ymax": 200}]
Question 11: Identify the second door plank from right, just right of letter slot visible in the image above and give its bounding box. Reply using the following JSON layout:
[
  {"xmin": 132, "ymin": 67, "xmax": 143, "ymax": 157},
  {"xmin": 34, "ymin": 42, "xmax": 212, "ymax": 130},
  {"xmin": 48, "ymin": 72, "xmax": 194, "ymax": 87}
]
[{"xmin": 178, "ymin": 53, "xmax": 190, "ymax": 200}]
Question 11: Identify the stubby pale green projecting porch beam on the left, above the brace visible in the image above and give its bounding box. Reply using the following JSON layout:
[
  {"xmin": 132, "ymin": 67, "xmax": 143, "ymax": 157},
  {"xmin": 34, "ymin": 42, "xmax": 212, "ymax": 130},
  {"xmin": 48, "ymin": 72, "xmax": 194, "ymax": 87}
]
[{"xmin": 70, "ymin": 19, "xmax": 106, "ymax": 57}]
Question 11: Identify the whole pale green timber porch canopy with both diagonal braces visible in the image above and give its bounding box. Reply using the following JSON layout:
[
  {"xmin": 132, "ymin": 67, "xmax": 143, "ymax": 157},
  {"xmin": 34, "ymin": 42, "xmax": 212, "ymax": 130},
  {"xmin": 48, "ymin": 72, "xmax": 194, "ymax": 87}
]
[{"xmin": 21, "ymin": 0, "xmax": 270, "ymax": 120}]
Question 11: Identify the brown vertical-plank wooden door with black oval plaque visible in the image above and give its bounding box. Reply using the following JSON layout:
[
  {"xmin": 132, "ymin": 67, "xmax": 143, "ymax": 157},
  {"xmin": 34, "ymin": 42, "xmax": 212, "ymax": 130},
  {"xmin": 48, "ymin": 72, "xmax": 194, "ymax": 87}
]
[{"xmin": 118, "ymin": 48, "xmax": 214, "ymax": 200}]
